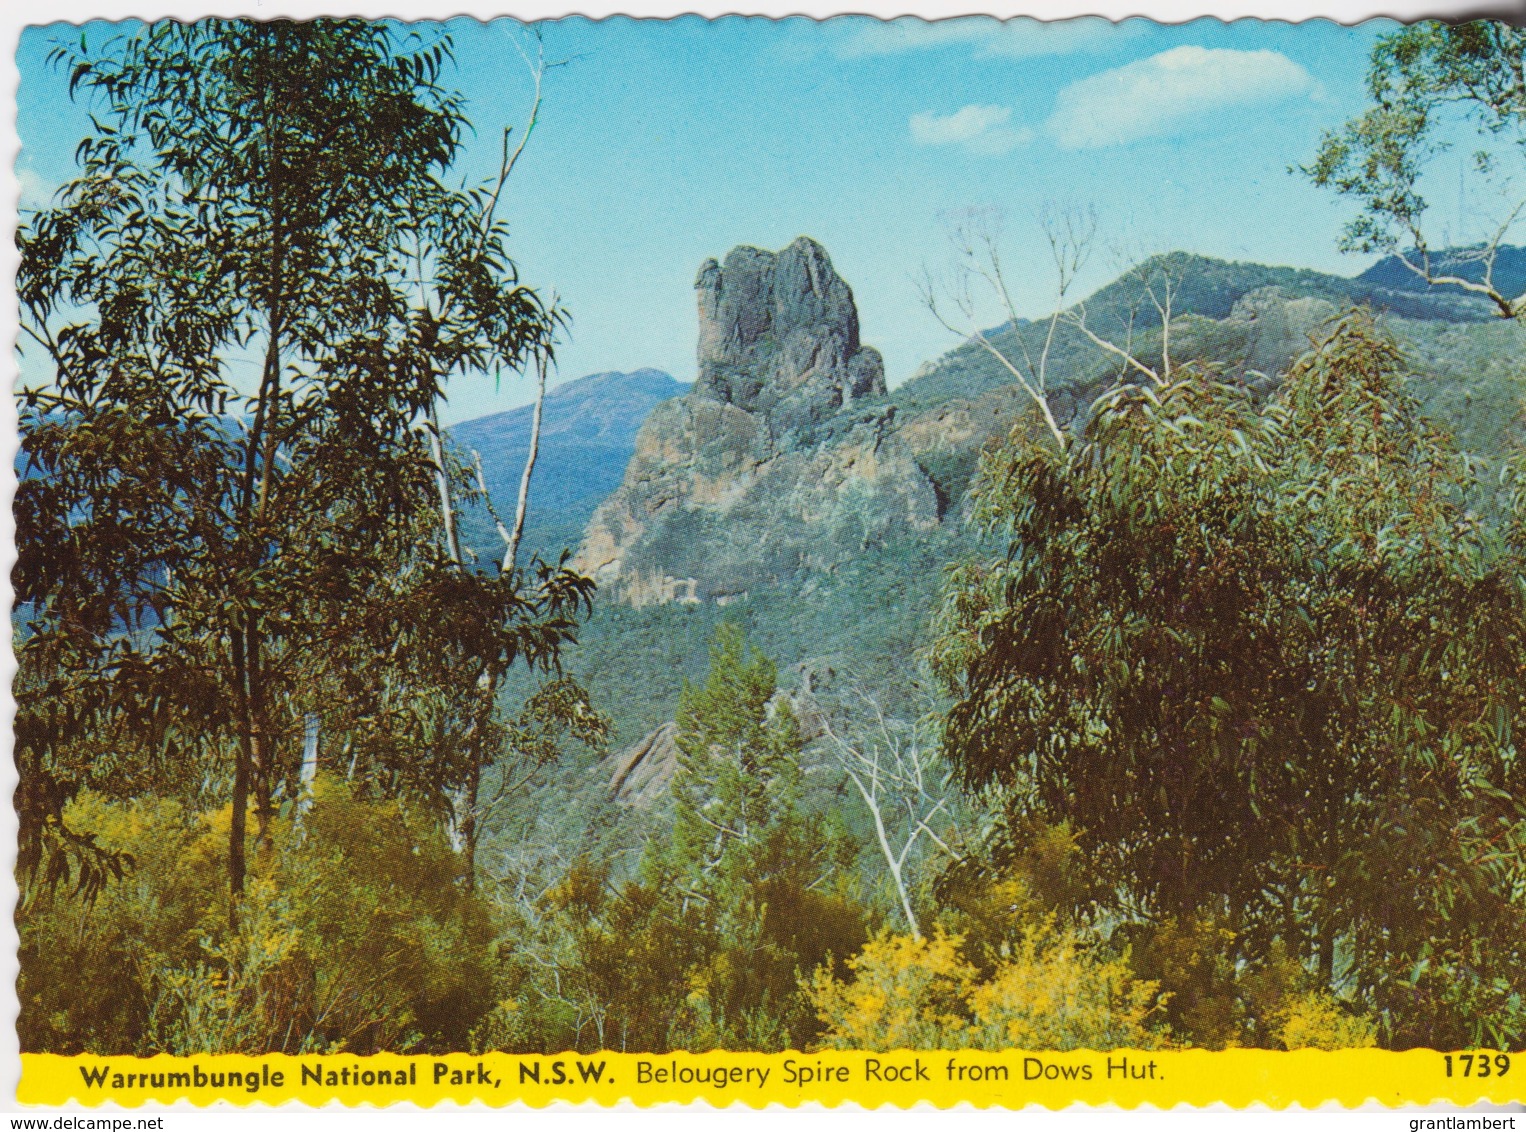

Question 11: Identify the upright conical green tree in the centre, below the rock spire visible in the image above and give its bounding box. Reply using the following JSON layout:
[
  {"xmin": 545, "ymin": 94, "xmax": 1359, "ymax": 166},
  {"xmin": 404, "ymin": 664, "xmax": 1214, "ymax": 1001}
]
[{"xmin": 645, "ymin": 622, "xmax": 862, "ymax": 1048}]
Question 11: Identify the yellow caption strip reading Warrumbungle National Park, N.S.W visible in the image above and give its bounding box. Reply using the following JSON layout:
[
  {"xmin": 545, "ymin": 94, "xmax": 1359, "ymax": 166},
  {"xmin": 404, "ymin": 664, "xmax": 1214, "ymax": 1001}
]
[{"xmin": 17, "ymin": 1050, "xmax": 1526, "ymax": 1108}]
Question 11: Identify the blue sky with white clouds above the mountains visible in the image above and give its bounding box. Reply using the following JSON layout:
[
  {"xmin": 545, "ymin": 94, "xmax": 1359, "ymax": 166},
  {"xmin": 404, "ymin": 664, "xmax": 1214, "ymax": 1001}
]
[{"xmin": 17, "ymin": 17, "xmax": 1428, "ymax": 420}]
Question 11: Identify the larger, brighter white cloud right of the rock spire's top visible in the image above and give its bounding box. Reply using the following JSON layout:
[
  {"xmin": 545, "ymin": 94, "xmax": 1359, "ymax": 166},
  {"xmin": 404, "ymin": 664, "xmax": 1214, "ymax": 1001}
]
[{"xmin": 1045, "ymin": 47, "xmax": 1318, "ymax": 150}]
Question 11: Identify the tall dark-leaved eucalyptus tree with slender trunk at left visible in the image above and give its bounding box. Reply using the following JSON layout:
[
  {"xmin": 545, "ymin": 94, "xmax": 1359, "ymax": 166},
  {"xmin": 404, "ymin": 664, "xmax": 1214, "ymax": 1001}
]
[{"xmin": 17, "ymin": 20, "xmax": 591, "ymax": 903}]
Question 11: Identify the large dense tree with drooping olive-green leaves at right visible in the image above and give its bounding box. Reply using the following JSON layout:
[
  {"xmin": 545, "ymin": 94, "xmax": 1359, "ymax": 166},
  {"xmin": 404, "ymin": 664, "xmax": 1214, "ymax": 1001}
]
[{"xmin": 937, "ymin": 319, "xmax": 1526, "ymax": 1045}]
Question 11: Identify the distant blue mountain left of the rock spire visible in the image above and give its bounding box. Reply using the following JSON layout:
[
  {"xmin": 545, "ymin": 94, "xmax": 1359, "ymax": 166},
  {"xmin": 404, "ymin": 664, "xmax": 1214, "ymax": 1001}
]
[{"xmin": 450, "ymin": 369, "xmax": 688, "ymax": 560}]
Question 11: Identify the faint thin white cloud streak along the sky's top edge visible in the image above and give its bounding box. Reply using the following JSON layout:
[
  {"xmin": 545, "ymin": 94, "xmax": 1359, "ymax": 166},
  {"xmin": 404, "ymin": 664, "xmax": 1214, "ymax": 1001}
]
[{"xmin": 832, "ymin": 15, "xmax": 1132, "ymax": 59}]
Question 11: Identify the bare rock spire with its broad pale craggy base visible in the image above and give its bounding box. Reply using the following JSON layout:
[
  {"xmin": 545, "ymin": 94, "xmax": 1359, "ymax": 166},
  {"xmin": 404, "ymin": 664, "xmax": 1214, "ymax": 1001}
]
[{"xmin": 577, "ymin": 236, "xmax": 940, "ymax": 606}]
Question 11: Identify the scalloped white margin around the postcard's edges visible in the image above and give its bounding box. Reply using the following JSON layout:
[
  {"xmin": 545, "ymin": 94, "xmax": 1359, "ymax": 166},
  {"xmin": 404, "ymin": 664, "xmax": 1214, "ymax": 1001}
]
[{"xmin": 0, "ymin": 0, "xmax": 1526, "ymax": 1132}]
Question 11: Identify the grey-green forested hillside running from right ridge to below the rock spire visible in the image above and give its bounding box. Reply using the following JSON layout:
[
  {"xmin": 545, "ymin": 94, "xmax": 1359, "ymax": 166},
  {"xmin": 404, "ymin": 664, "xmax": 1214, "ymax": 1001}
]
[{"xmin": 546, "ymin": 249, "xmax": 1523, "ymax": 771}]
